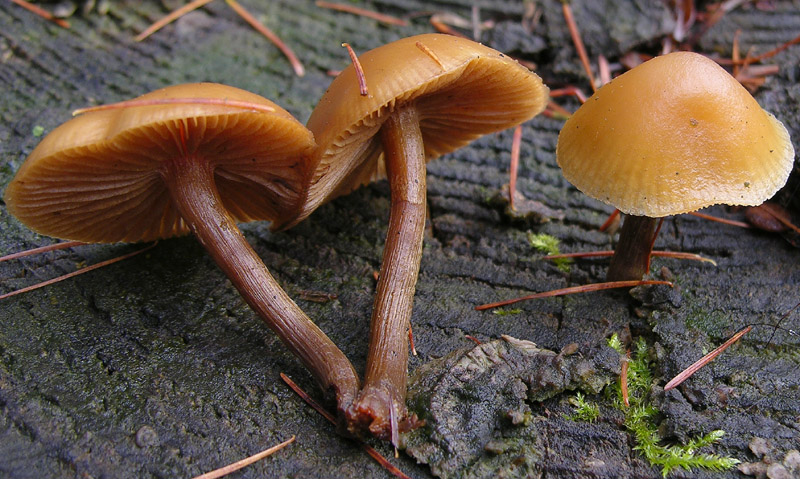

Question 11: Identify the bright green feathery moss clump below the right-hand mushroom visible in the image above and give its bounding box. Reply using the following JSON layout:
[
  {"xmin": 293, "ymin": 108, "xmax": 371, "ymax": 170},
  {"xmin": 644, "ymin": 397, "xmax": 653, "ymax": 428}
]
[{"xmin": 608, "ymin": 334, "xmax": 739, "ymax": 477}]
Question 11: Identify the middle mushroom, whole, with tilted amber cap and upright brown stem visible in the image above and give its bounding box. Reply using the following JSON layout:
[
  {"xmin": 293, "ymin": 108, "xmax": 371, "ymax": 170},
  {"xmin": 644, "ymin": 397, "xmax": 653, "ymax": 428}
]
[{"xmin": 289, "ymin": 34, "xmax": 548, "ymax": 445}]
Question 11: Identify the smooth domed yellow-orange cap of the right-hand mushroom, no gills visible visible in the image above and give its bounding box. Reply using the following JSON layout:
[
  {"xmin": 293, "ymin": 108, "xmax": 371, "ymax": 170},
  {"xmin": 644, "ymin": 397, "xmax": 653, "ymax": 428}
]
[{"xmin": 556, "ymin": 52, "xmax": 794, "ymax": 217}]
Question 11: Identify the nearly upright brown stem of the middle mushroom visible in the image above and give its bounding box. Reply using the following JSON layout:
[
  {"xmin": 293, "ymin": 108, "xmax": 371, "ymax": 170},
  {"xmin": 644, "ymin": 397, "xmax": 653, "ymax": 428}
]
[{"xmin": 351, "ymin": 106, "xmax": 425, "ymax": 445}]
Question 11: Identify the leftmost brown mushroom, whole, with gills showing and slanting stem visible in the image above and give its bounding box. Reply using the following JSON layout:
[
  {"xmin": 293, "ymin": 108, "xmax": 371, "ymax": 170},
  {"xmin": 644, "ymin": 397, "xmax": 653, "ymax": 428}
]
[{"xmin": 5, "ymin": 83, "xmax": 358, "ymax": 420}]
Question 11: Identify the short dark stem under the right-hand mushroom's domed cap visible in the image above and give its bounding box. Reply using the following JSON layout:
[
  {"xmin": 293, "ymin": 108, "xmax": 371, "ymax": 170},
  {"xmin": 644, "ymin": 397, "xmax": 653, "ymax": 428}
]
[{"xmin": 606, "ymin": 215, "xmax": 658, "ymax": 281}]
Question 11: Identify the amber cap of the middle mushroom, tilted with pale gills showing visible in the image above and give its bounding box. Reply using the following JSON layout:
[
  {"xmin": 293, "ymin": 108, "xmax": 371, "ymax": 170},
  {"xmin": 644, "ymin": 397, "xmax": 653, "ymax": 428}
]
[{"xmin": 296, "ymin": 34, "xmax": 548, "ymax": 225}]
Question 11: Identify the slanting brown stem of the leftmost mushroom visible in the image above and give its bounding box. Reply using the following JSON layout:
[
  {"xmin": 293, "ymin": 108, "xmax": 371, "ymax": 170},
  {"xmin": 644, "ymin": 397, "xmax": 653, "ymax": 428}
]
[{"xmin": 161, "ymin": 154, "xmax": 359, "ymax": 417}]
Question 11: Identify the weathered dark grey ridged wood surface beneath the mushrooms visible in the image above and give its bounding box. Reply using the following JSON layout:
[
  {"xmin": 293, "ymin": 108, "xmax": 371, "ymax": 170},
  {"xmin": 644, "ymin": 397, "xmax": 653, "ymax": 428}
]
[{"xmin": 0, "ymin": 0, "xmax": 800, "ymax": 479}]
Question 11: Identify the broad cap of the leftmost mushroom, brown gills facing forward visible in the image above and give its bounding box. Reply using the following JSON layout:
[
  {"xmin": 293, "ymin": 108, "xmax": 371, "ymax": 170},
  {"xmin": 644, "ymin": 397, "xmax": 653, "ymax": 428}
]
[{"xmin": 5, "ymin": 83, "xmax": 314, "ymax": 243}]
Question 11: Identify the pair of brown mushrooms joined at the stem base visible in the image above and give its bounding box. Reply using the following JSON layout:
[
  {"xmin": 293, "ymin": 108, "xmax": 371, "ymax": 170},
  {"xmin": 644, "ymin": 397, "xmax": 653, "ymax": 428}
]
[{"xmin": 5, "ymin": 34, "xmax": 548, "ymax": 445}]
